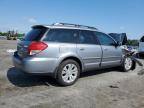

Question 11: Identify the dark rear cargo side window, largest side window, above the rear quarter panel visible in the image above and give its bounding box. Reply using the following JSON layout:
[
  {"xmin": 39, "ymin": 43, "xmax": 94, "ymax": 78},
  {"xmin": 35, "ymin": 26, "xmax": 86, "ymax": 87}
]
[{"xmin": 44, "ymin": 29, "xmax": 78, "ymax": 43}]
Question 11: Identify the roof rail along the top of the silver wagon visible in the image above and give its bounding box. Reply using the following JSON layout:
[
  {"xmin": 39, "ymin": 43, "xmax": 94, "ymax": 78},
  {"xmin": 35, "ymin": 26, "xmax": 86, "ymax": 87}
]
[{"xmin": 52, "ymin": 23, "xmax": 97, "ymax": 30}]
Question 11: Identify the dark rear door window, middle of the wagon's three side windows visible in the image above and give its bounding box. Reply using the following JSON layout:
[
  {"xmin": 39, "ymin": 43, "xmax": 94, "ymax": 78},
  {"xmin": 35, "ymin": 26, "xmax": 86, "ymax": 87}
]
[{"xmin": 79, "ymin": 30, "xmax": 98, "ymax": 44}]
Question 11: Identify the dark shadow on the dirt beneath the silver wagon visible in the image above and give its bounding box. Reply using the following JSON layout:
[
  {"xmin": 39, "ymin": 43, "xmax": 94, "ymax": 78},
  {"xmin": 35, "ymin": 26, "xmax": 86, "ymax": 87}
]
[{"xmin": 7, "ymin": 67, "xmax": 121, "ymax": 87}]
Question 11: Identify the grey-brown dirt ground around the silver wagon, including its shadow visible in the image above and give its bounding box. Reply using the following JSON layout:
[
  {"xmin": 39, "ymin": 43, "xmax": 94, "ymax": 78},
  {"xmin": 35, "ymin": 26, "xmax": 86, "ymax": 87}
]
[{"xmin": 0, "ymin": 40, "xmax": 144, "ymax": 108}]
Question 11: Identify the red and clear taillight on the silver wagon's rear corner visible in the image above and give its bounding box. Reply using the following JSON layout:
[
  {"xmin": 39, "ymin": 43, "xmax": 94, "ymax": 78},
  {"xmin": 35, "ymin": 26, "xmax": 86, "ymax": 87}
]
[{"xmin": 28, "ymin": 42, "xmax": 48, "ymax": 55}]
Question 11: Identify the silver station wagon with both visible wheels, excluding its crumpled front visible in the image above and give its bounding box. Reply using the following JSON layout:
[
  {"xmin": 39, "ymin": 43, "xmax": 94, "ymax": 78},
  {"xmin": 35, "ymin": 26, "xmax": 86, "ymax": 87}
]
[{"xmin": 13, "ymin": 23, "xmax": 133, "ymax": 86}]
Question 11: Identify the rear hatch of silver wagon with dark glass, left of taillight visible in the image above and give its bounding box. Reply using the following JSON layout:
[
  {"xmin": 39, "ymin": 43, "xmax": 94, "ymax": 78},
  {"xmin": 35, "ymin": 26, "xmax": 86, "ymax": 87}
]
[{"xmin": 17, "ymin": 26, "xmax": 48, "ymax": 58}]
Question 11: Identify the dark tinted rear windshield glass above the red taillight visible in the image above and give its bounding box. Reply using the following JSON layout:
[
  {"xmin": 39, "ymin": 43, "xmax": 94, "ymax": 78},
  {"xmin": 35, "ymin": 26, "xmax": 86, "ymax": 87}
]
[{"xmin": 23, "ymin": 27, "xmax": 47, "ymax": 41}]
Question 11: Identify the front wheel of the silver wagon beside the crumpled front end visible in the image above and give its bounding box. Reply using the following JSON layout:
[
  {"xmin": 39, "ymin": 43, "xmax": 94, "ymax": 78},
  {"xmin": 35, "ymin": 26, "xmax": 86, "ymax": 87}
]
[{"xmin": 121, "ymin": 57, "xmax": 134, "ymax": 72}]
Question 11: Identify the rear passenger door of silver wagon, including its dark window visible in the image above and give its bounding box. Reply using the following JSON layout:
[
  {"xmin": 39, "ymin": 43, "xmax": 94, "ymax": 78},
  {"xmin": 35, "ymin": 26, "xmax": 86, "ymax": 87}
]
[{"xmin": 77, "ymin": 30, "xmax": 102, "ymax": 70}]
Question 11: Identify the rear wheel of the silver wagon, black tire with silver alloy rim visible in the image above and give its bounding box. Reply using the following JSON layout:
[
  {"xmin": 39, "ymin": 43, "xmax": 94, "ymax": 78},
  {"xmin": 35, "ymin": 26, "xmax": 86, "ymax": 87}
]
[{"xmin": 57, "ymin": 59, "xmax": 80, "ymax": 86}]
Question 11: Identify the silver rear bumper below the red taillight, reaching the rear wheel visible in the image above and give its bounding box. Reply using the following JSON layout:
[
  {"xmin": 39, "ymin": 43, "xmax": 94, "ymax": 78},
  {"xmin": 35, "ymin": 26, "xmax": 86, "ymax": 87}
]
[{"xmin": 13, "ymin": 53, "xmax": 57, "ymax": 74}]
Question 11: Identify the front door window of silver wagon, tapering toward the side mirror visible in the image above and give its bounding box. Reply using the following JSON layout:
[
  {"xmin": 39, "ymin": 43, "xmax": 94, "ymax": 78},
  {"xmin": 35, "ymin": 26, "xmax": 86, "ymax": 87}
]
[{"xmin": 95, "ymin": 32, "xmax": 115, "ymax": 46}]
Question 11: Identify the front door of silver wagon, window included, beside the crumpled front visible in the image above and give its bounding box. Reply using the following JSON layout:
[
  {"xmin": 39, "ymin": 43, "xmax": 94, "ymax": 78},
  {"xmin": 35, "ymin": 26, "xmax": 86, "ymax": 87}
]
[{"xmin": 95, "ymin": 32, "xmax": 122, "ymax": 67}]
